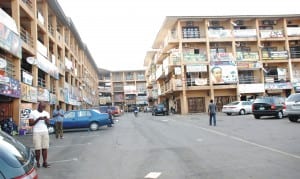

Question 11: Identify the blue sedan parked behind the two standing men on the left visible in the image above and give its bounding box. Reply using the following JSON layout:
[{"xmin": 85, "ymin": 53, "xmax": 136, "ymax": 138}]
[{"xmin": 48, "ymin": 109, "xmax": 113, "ymax": 133}]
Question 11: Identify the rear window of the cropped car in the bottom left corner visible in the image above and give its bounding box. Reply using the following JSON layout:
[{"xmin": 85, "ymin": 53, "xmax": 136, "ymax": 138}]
[{"xmin": 0, "ymin": 131, "xmax": 30, "ymax": 167}]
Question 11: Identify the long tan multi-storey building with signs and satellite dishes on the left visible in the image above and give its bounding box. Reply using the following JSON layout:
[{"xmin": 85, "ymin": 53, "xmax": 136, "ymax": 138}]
[{"xmin": 0, "ymin": 0, "xmax": 99, "ymax": 131}]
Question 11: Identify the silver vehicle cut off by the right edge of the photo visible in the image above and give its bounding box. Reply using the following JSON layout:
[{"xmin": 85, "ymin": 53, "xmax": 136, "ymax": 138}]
[{"xmin": 285, "ymin": 93, "xmax": 300, "ymax": 122}]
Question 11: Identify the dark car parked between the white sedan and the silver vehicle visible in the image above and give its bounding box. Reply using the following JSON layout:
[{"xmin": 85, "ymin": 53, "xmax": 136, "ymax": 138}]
[{"xmin": 252, "ymin": 96, "xmax": 285, "ymax": 119}]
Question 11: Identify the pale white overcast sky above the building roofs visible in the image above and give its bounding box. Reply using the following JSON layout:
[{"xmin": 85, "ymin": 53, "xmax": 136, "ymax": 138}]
[{"xmin": 58, "ymin": 0, "xmax": 300, "ymax": 71}]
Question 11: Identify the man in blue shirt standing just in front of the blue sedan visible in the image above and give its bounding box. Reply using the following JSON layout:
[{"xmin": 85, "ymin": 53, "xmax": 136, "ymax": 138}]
[{"xmin": 53, "ymin": 105, "xmax": 65, "ymax": 139}]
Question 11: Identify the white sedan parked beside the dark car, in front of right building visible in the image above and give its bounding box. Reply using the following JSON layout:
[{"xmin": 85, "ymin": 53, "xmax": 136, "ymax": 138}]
[{"xmin": 222, "ymin": 101, "xmax": 252, "ymax": 115}]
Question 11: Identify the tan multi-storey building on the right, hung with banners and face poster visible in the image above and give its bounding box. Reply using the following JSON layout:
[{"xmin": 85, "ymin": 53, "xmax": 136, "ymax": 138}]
[{"xmin": 144, "ymin": 15, "xmax": 300, "ymax": 114}]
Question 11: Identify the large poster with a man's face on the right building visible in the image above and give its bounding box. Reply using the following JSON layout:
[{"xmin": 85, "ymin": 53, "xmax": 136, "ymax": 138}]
[{"xmin": 210, "ymin": 63, "xmax": 238, "ymax": 84}]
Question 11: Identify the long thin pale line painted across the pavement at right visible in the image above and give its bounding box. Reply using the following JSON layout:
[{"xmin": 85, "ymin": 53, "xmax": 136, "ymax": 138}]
[{"xmin": 199, "ymin": 127, "xmax": 300, "ymax": 159}]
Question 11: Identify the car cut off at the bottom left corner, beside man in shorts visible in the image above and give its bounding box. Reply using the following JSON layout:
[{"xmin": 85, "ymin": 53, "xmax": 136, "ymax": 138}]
[{"xmin": 0, "ymin": 131, "xmax": 38, "ymax": 179}]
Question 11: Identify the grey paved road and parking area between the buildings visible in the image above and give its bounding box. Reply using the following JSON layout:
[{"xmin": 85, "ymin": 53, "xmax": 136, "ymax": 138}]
[{"xmin": 18, "ymin": 113, "xmax": 300, "ymax": 179}]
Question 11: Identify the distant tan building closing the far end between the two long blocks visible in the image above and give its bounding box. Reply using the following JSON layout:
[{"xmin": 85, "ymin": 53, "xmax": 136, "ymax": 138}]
[{"xmin": 99, "ymin": 69, "xmax": 148, "ymax": 111}]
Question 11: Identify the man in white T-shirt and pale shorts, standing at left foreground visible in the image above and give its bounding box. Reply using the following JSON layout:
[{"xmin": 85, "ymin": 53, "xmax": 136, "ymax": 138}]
[{"xmin": 29, "ymin": 102, "xmax": 50, "ymax": 168}]
